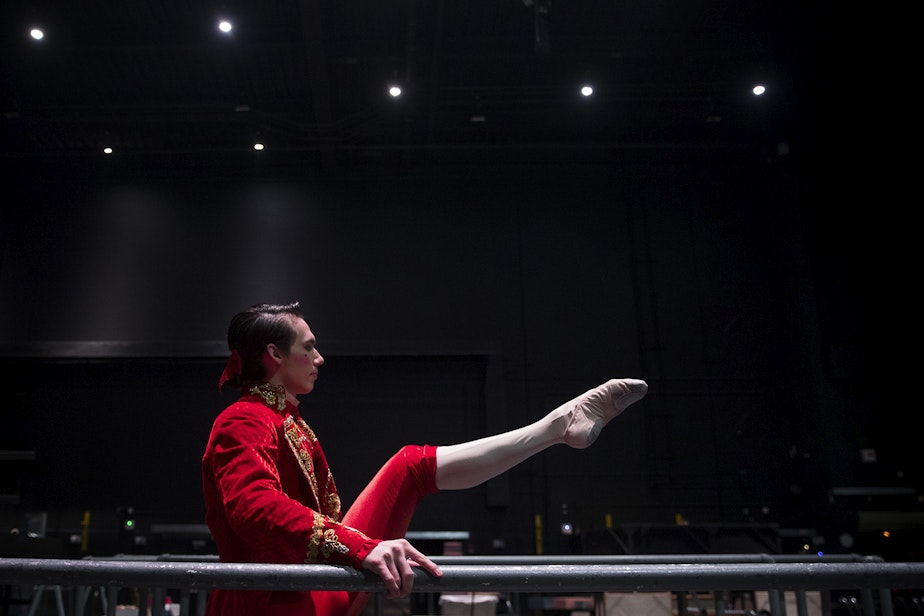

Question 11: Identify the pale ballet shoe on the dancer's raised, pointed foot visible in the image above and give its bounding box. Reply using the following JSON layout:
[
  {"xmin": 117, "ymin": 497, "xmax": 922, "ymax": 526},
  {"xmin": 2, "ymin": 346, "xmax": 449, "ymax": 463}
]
[{"xmin": 564, "ymin": 379, "xmax": 648, "ymax": 449}]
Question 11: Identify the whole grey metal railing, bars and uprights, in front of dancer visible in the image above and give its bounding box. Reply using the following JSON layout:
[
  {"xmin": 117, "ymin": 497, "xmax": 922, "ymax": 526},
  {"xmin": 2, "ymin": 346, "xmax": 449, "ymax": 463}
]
[{"xmin": 0, "ymin": 554, "xmax": 924, "ymax": 616}]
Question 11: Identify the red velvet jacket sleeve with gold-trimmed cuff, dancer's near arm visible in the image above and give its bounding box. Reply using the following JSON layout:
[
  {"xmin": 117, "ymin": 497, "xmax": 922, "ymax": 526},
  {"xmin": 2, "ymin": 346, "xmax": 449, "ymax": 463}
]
[{"xmin": 208, "ymin": 405, "xmax": 380, "ymax": 569}]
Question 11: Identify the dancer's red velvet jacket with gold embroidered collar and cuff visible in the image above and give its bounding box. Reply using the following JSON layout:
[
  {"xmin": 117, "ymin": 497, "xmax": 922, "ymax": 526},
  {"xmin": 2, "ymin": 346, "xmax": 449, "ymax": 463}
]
[{"xmin": 202, "ymin": 394, "xmax": 380, "ymax": 614}]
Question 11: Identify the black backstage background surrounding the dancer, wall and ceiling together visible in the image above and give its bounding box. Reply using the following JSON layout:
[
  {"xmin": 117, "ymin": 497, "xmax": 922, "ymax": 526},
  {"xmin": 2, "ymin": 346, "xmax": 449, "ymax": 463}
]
[{"xmin": 0, "ymin": 2, "xmax": 908, "ymax": 560}]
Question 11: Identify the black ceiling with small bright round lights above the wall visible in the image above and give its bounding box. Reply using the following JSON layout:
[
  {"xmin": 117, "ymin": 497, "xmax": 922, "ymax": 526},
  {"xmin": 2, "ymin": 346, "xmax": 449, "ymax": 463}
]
[{"xmin": 0, "ymin": 0, "xmax": 811, "ymax": 168}]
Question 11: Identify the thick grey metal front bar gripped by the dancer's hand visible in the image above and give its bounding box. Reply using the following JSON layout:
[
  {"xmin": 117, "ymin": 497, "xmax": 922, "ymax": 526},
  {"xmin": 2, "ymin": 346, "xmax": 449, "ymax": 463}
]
[{"xmin": 0, "ymin": 558, "xmax": 924, "ymax": 592}]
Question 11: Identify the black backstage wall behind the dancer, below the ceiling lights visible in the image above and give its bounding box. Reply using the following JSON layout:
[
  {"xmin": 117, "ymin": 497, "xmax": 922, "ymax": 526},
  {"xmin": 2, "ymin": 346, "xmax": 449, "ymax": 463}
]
[{"xmin": 0, "ymin": 157, "xmax": 904, "ymax": 553}]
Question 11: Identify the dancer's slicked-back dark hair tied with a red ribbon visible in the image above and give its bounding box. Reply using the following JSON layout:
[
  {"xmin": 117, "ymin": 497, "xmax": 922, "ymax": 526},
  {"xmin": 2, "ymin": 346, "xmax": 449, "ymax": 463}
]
[{"xmin": 228, "ymin": 302, "xmax": 303, "ymax": 387}]
